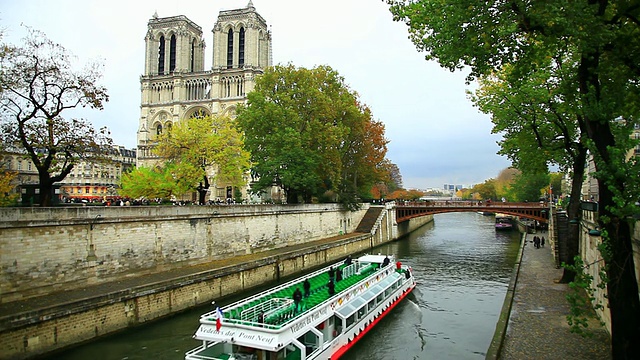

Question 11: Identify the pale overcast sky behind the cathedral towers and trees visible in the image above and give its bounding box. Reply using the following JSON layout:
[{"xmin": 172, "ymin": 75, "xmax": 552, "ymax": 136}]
[{"xmin": 0, "ymin": 0, "xmax": 509, "ymax": 189}]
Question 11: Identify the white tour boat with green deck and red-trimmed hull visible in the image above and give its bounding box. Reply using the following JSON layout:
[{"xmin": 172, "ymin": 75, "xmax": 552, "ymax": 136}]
[{"xmin": 185, "ymin": 254, "xmax": 416, "ymax": 360}]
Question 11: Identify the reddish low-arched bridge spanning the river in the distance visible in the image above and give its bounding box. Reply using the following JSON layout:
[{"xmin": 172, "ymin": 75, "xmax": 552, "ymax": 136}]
[{"xmin": 396, "ymin": 200, "xmax": 549, "ymax": 223}]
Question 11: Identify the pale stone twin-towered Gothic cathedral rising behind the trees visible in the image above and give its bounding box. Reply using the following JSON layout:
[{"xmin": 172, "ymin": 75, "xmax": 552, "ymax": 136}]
[{"xmin": 137, "ymin": 1, "xmax": 272, "ymax": 199}]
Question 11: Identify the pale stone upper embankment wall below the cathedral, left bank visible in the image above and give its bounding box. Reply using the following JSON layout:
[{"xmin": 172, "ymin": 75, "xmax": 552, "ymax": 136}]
[{"xmin": 0, "ymin": 204, "xmax": 368, "ymax": 303}]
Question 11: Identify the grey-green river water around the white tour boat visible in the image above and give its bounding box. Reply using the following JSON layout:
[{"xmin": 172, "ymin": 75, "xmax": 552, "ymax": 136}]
[{"xmin": 49, "ymin": 213, "xmax": 520, "ymax": 360}]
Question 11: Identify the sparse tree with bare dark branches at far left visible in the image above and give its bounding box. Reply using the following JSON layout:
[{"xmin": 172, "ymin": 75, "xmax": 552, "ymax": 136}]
[{"xmin": 0, "ymin": 29, "xmax": 112, "ymax": 206}]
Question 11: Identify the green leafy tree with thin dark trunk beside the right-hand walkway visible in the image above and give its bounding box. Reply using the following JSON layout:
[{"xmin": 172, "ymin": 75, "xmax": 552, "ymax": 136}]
[{"xmin": 472, "ymin": 66, "xmax": 587, "ymax": 282}]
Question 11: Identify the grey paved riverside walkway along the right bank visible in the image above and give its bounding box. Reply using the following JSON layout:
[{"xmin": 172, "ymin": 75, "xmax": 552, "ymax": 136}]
[{"xmin": 498, "ymin": 233, "xmax": 612, "ymax": 360}]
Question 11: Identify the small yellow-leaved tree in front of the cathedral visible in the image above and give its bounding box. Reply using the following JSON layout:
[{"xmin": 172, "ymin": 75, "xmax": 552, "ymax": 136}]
[{"xmin": 155, "ymin": 116, "xmax": 249, "ymax": 204}]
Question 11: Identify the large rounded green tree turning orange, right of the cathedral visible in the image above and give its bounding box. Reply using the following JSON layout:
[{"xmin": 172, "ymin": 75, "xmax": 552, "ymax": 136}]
[{"xmin": 236, "ymin": 65, "xmax": 386, "ymax": 207}]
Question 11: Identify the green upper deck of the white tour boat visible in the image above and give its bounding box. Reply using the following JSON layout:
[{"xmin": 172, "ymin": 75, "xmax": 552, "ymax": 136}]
[{"xmin": 203, "ymin": 262, "xmax": 404, "ymax": 329}]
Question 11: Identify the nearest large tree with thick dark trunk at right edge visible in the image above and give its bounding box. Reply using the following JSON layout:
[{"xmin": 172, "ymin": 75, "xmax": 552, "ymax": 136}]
[{"xmin": 387, "ymin": 0, "xmax": 640, "ymax": 359}]
